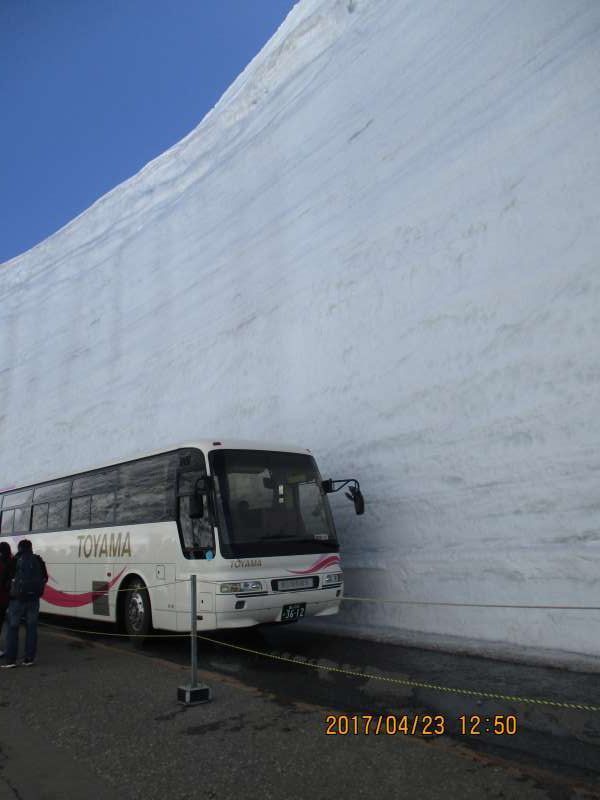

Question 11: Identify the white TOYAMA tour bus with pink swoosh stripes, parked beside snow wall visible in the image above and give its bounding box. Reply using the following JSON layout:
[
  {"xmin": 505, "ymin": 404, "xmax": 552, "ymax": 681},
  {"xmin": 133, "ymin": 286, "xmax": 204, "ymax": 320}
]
[{"xmin": 0, "ymin": 441, "xmax": 364, "ymax": 637}]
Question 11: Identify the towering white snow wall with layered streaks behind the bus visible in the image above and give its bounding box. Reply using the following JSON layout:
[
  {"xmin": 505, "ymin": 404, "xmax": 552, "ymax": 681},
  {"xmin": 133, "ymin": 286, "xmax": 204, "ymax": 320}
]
[{"xmin": 0, "ymin": 0, "xmax": 600, "ymax": 662}]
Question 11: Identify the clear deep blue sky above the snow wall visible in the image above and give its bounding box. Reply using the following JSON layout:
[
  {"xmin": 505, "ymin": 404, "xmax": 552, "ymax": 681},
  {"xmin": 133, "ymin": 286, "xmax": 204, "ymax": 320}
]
[{"xmin": 0, "ymin": 0, "xmax": 295, "ymax": 263}]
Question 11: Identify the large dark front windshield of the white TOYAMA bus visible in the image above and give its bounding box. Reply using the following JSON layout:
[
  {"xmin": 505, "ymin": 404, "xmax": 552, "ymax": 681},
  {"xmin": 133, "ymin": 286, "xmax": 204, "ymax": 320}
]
[{"xmin": 210, "ymin": 450, "xmax": 338, "ymax": 558}]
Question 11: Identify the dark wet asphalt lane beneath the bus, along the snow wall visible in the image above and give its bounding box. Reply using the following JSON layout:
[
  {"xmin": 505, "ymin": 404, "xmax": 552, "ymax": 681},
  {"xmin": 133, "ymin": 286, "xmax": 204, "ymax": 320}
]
[{"xmin": 35, "ymin": 617, "xmax": 600, "ymax": 799}]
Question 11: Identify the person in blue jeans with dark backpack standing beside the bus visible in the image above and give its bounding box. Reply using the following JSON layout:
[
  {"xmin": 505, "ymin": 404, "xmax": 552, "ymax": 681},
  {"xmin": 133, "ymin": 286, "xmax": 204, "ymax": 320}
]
[{"xmin": 2, "ymin": 539, "xmax": 48, "ymax": 669}]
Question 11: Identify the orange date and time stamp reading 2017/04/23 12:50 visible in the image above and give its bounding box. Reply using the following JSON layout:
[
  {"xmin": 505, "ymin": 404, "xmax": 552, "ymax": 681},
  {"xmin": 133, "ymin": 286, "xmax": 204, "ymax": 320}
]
[{"xmin": 325, "ymin": 714, "xmax": 517, "ymax": 736}]
